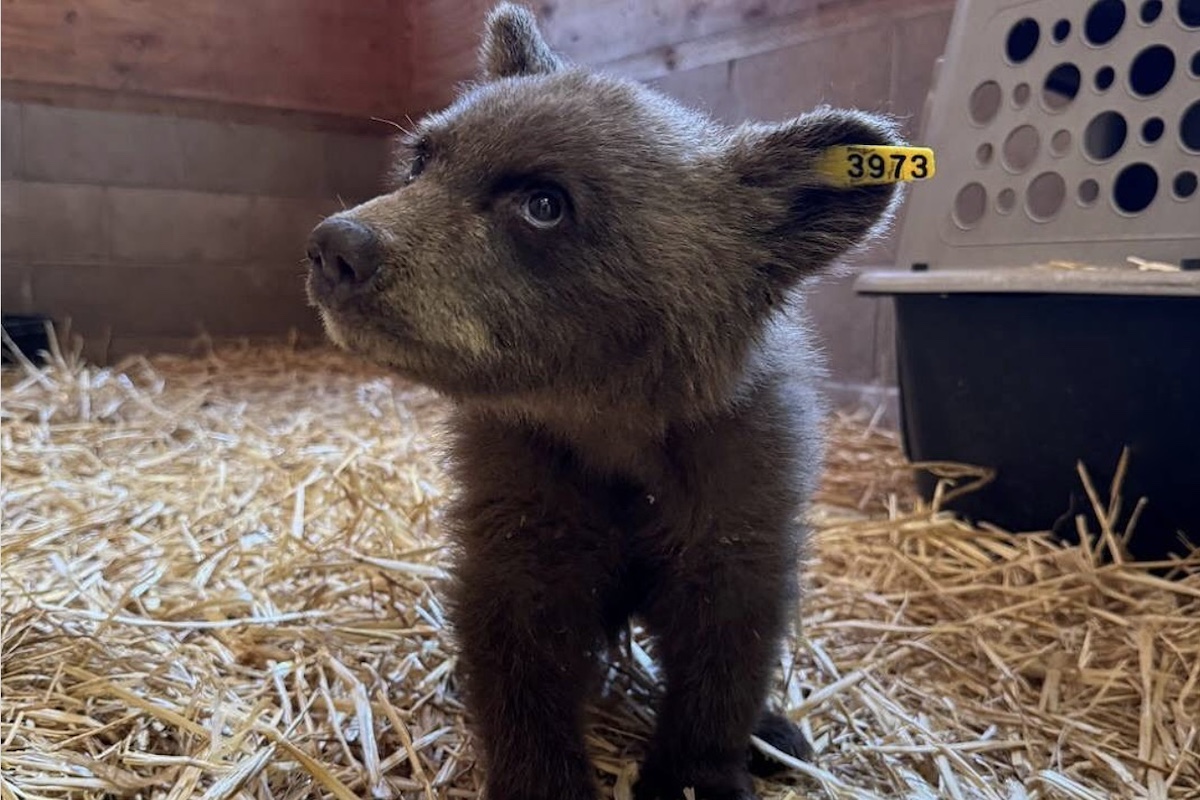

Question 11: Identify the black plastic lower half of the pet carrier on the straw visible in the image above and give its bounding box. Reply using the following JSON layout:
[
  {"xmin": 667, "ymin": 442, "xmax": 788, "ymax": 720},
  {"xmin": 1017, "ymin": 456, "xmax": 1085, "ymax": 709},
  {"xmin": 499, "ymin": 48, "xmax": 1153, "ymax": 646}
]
[{"xmin": 859, "ymin": 271, "xmax": 1200, "ymax": 560}]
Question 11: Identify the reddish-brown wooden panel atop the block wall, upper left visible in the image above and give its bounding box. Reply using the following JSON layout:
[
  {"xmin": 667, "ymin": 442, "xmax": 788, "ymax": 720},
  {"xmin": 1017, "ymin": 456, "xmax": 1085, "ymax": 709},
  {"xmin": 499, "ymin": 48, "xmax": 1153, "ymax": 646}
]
[{"xmin": 2, "ymin": 0, "xmax": 409, "ymax": 115}]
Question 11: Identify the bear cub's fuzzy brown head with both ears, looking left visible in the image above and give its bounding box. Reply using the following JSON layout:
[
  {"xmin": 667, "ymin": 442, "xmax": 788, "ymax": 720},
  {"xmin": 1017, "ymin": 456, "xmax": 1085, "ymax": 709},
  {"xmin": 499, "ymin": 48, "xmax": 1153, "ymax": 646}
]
[{"xmin": 307, "ymin": 4, "xmax": 900, "ymax": 419}]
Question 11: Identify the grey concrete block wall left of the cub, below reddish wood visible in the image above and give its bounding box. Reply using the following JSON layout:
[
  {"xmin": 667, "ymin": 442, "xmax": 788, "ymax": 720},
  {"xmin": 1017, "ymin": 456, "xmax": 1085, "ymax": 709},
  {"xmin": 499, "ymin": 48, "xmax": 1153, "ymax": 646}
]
[{"xmin": 0, "ymin": 98, "xmax": 390, "ymax": 361}]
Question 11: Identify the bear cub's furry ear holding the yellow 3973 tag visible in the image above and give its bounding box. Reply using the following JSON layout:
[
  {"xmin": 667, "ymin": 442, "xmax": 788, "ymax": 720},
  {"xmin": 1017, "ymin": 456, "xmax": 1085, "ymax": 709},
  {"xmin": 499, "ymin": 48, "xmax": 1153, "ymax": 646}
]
[{"xmin": 725, "ymin": 108, "xmax": 904, "ymax": 281}]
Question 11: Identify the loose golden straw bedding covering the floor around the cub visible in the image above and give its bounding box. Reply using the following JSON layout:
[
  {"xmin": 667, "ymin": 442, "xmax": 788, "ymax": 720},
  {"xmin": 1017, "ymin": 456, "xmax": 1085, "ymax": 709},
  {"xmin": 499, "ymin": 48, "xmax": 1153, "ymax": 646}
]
[{"xmin": 0, "ymin": 347, "xmax": 1200, "ymax": 800}]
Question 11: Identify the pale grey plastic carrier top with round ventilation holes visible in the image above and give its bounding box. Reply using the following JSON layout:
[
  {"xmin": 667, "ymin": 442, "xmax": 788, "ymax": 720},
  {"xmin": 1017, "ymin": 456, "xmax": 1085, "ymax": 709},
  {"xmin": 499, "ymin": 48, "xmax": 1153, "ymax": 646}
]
[{"xmin": 899, "ymin": 0, "xmax": 1200, "ymax": 272}]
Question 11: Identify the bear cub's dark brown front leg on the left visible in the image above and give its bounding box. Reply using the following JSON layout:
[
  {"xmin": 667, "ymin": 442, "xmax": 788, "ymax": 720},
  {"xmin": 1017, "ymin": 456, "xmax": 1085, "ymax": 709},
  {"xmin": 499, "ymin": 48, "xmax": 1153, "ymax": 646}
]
[{"xmin": 449, "ymin": 419, "xmax": 620, "ymax": 800}]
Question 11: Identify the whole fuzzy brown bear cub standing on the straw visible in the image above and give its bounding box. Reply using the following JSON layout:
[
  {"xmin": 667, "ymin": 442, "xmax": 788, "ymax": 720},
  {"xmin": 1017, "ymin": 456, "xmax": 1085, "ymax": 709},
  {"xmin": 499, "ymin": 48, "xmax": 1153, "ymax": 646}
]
[{"xmin": 308, "ymin": 5, "xmax": 899, "ymax": 800}]
